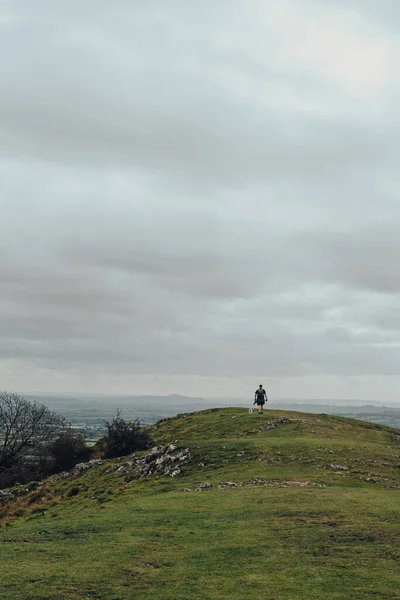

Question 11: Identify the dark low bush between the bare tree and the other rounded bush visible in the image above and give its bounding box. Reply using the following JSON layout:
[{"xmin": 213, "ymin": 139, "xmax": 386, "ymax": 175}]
[{"xmin": 49, "ymin": 429, "xmax": 91, "ymax": 472}]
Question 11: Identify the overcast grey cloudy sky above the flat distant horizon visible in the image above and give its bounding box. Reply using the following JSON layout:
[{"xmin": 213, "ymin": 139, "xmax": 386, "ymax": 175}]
[{"xmin": 0, "ymin": 0, "xmax": 400, "ymax": 402}]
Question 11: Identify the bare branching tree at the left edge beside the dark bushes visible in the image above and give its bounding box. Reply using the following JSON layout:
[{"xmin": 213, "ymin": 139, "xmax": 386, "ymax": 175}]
[{"xmin": 0, "ymin": 392, "xmax": 64, "ymax": 485}]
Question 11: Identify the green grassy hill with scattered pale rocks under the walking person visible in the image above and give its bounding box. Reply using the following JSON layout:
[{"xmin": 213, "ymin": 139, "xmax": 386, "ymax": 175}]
[{"xmin": 0, "ymin": 408, "xmax": 400, "ymax": 600}]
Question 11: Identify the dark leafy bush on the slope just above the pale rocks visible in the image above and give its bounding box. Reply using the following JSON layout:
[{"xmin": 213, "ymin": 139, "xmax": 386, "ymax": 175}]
[{"xmin": 104, "ymin": 412, "xmax": 154, "ymax": 458}]
